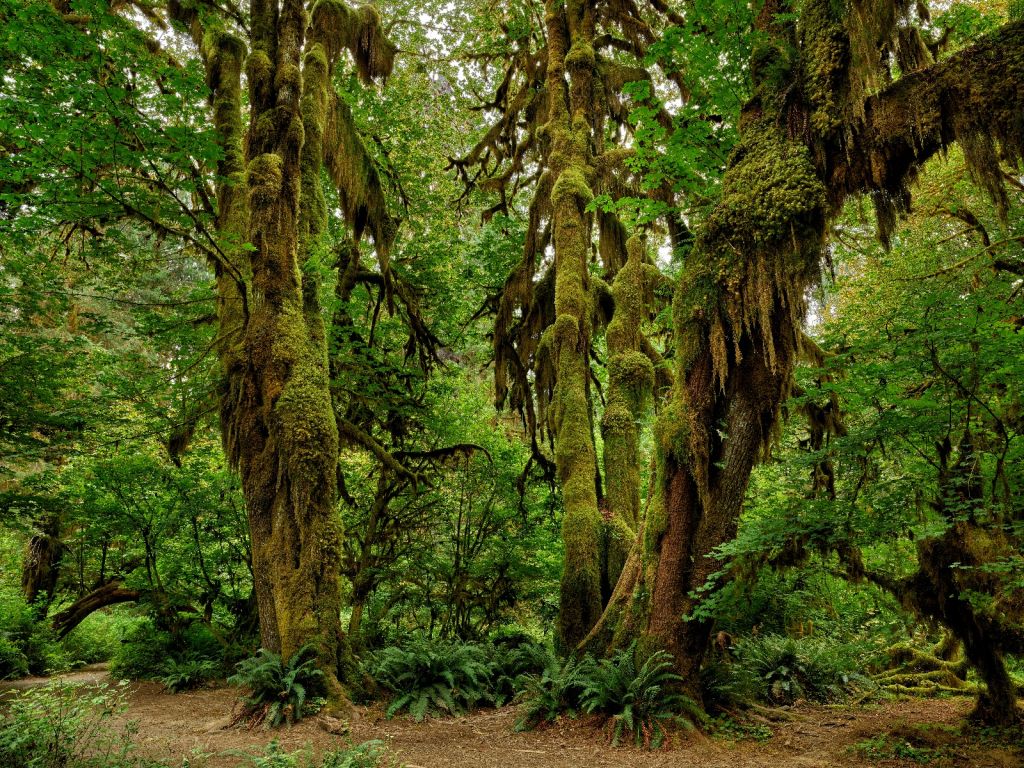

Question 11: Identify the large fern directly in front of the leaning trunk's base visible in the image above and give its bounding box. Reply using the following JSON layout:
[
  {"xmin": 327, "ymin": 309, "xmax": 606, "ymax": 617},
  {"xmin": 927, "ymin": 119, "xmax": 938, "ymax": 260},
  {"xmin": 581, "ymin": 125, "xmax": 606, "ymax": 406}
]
[{"xmin": 580, "ymin": 645, "xmax": 703, "ymax": 749}]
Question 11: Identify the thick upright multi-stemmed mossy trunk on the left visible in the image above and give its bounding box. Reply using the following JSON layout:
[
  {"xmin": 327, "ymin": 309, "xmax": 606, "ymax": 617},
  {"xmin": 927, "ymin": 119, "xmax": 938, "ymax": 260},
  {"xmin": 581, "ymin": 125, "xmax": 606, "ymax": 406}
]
[{"xmin": 170, "ymin": 0, "xmax": 393, "ymax": 703}]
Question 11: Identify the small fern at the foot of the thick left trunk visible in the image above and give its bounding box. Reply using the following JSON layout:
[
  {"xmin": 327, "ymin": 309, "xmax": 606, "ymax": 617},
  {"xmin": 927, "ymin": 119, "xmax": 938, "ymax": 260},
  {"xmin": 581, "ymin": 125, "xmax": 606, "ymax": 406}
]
[{"xmin": 227, "ymin": 645, "xmax": 324, "ymax": 728}]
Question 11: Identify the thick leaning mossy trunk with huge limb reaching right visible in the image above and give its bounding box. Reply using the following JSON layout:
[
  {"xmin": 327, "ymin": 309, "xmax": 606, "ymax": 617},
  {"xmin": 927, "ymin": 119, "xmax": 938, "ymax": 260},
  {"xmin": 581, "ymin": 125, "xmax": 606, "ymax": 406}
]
[{"xmin": 605, "ymin": 0, "xmax": 1024, "ymax": 716}]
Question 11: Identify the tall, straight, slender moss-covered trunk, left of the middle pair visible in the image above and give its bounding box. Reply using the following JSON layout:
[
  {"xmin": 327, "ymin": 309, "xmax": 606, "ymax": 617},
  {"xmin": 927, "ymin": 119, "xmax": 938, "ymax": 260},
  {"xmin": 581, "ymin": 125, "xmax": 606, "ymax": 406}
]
[{"xmin": 543, "ymin": 0, "xmax": 602, "ymax": 648}]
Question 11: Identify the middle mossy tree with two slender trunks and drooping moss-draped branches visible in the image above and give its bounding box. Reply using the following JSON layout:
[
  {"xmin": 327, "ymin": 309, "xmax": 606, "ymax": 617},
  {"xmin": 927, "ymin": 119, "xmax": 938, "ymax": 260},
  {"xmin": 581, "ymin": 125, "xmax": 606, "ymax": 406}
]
[{"xmin": 453, "ymin": 0, "xmax": 686, "ymax": 649}]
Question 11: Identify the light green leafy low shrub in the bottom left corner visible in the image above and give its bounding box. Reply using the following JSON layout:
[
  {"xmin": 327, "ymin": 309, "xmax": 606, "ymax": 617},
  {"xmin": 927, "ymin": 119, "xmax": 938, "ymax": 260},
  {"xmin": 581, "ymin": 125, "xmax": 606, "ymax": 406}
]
[{"xmin": 0, "ymin": 682, "xmax": 151, "ymax": 768}]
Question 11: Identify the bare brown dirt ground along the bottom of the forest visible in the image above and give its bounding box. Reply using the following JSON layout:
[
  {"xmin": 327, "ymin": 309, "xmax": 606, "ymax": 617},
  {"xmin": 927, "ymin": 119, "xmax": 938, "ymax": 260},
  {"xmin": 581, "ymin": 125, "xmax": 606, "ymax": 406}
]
[{"xmin": 2, "ymin": 670, "xmax": 1024, "ymax": 768}]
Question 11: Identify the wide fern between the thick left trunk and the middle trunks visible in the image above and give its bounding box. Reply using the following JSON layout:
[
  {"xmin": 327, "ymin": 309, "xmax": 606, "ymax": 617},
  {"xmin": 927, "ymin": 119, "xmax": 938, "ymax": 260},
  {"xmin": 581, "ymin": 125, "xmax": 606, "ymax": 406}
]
[{"xmin": 365, "ymin": 638, "xmax": 490, "ymax": 722}]
